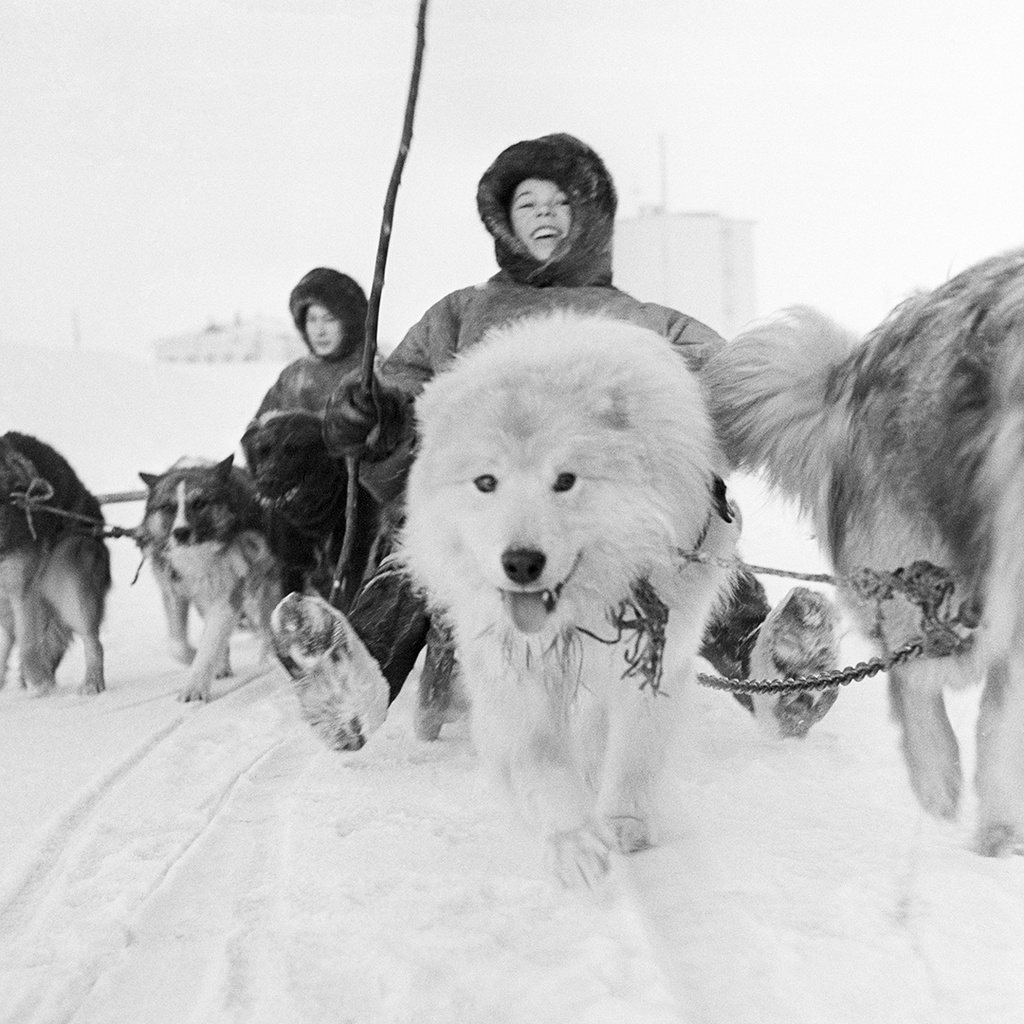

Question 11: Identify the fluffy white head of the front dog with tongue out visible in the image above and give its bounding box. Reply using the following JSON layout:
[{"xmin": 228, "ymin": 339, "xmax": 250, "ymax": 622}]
[{"xmin": 406, "ymin": 317, "xmax": 733, "ymax": 633}]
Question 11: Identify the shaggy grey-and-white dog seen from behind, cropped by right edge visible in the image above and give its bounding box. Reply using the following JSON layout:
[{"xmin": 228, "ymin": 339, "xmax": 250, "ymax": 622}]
[{"xmin": 708, "ymin": 249, "xmax": 1024, "ymax": 856}]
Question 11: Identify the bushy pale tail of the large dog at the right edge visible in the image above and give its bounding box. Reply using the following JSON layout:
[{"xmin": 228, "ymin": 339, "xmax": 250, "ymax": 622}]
[{"xmin": 703, "ymin": 306, "xmax": 858, "ymax": 506}]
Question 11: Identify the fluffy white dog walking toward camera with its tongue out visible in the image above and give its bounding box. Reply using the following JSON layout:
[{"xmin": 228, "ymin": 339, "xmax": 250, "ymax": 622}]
[{"xmin": 395, "ymin": 313, "xmax": 739, "ymax": 885}]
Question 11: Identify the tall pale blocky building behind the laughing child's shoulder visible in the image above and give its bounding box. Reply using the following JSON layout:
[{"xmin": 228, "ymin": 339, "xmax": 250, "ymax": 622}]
[{"xmin": 612, "ymin": 207, "xmax": 757, "ymax": 338}]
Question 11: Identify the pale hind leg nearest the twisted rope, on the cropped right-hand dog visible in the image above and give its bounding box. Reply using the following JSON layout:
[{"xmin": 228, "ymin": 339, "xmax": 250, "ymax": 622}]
[{"xmin": 889, "ymin": 665, "xmax": 962, "ymax": 819}]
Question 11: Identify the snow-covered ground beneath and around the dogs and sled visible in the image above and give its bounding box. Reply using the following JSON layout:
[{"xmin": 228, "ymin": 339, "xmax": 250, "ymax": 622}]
[{"xmin": 0, "ymin": 348, "xmax": 1024, "ymax": 1024}]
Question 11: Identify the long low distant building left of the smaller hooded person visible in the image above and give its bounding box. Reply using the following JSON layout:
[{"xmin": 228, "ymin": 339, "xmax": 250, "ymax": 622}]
[{"xmin": 153, "ymin": 316, "xmax": 307, "ymax": 362}]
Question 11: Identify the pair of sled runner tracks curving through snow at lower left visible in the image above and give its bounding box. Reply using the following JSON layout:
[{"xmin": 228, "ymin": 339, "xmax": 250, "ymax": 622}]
[{"xmin": 0, "ymin": 670, "xmax": 288, "ymax": 1024}]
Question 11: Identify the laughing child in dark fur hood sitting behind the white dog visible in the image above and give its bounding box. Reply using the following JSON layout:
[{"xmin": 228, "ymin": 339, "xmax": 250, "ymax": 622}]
[{"xmin": 311, "ymin": 134, "xmax": 815, "ymax": 749}]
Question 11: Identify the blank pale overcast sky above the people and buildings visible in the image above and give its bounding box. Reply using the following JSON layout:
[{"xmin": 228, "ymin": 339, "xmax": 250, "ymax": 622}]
[{"xmin": 0, "ymin": 0, "xmax": 1024, "ymax": 352}]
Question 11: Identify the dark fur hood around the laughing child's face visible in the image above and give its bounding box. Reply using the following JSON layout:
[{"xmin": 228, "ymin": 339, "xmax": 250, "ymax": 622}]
[{"xmin": 476, "ymin": 134, "xmax": 616, "ymax": 288}]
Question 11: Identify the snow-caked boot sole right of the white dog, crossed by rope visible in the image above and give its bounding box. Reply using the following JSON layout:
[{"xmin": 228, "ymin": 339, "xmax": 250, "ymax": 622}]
[{"xmin": 750, "ymin": 587, "xmax": 839, "ymax": 737}]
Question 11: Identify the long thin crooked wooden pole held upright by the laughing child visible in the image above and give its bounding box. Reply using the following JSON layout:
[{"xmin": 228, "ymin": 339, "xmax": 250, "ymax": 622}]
[{"xmin": 330, "ymin": 0, "xmax": 427, "ymax": 609}]
